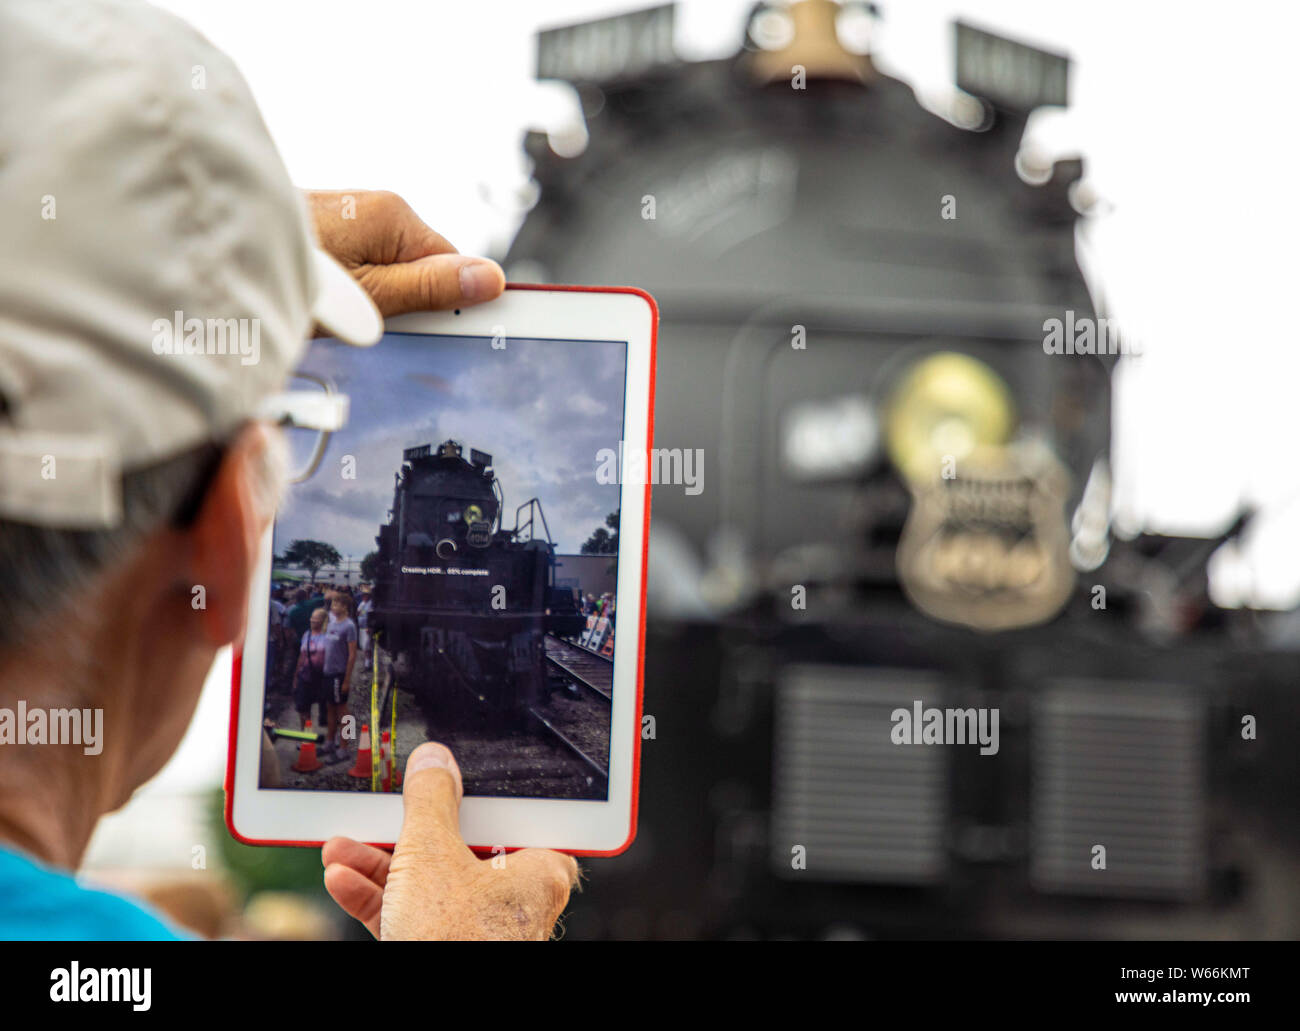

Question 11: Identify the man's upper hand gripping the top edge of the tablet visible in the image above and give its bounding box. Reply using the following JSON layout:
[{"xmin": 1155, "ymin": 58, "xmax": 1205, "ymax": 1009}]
[{"xmin": 307, "ymin": 190, "xmax": 506, "ymax": 316}]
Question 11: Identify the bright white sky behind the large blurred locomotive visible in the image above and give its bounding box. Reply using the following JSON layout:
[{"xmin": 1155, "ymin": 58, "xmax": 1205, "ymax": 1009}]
[{"xmin": 89, "ymin": 0, "xmax": 1300, "ymax": 852}]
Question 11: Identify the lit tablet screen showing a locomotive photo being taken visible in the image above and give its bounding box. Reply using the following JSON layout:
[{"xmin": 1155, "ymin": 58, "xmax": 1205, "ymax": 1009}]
[{"xmin": 259, "ymin": 333, "xmax": 632, "ymax": 801}]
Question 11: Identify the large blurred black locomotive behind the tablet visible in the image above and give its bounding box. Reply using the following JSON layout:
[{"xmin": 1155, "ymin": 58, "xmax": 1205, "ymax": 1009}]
[{"xmin": 504, "ymin": 0, "xmax": 1300, "ymax": 939}]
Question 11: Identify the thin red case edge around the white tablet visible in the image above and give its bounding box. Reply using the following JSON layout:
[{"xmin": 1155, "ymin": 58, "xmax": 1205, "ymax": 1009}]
[{"xmin": 225, "ymin": 283, "xmax": 659, "ymax": 855}]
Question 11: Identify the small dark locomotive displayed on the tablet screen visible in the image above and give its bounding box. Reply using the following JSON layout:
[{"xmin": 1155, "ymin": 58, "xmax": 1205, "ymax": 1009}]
[{"xmin": 371, "ymin": 441, "xmax": 585, "ymax": 711}]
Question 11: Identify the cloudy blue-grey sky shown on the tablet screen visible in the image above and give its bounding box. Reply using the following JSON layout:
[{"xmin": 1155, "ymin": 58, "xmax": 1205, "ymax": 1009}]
[{"xmin": 276, "ymin": 333, "xmax": 625, "ymax": 560}]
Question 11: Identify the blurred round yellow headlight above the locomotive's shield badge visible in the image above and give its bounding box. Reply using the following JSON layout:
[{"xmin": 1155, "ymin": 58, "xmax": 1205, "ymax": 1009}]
[{"xmin": 885, "ymin": 351, "xmax": 1015, "ymax": 482}]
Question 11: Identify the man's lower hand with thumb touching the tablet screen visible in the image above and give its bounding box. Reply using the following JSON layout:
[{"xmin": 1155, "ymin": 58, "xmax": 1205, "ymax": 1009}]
[{"xmin": 321, "ymin": 742, "xmax": 579, "ymax": 941}]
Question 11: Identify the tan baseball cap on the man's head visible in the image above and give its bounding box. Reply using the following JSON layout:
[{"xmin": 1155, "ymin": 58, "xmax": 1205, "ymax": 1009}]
[{"xmin": 0, "ymin": 0, "xmax": 384, "ymax": 529}]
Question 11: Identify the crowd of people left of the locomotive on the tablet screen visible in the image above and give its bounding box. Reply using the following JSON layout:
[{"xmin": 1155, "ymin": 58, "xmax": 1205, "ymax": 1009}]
[{"xmin": 267, "ymin": 584, "xmax": 374, "ymax": 759}]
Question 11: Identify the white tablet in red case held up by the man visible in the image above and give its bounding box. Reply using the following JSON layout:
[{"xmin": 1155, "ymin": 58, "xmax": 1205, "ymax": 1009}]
[{"xmin": 226, "ymin": 285, "xmax": 658, "ymax": 855}]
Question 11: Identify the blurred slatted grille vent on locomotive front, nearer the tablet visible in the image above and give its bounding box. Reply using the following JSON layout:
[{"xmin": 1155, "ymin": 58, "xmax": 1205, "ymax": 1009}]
[{"xmin": 771, "ymin": 666, "xmax": 949, "ymax": 884}]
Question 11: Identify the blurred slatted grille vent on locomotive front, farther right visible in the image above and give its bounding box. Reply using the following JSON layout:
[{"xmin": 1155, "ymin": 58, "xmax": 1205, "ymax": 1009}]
[{"xmin": 1030, "ymin": 681, "xmax": 1206, "ymax": 900}]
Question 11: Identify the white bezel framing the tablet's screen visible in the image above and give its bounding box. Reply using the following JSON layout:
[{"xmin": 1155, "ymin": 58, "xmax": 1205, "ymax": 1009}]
[{"xmin": 226, "ymin": 285, "xmax": 658, "ymax": 854}]
